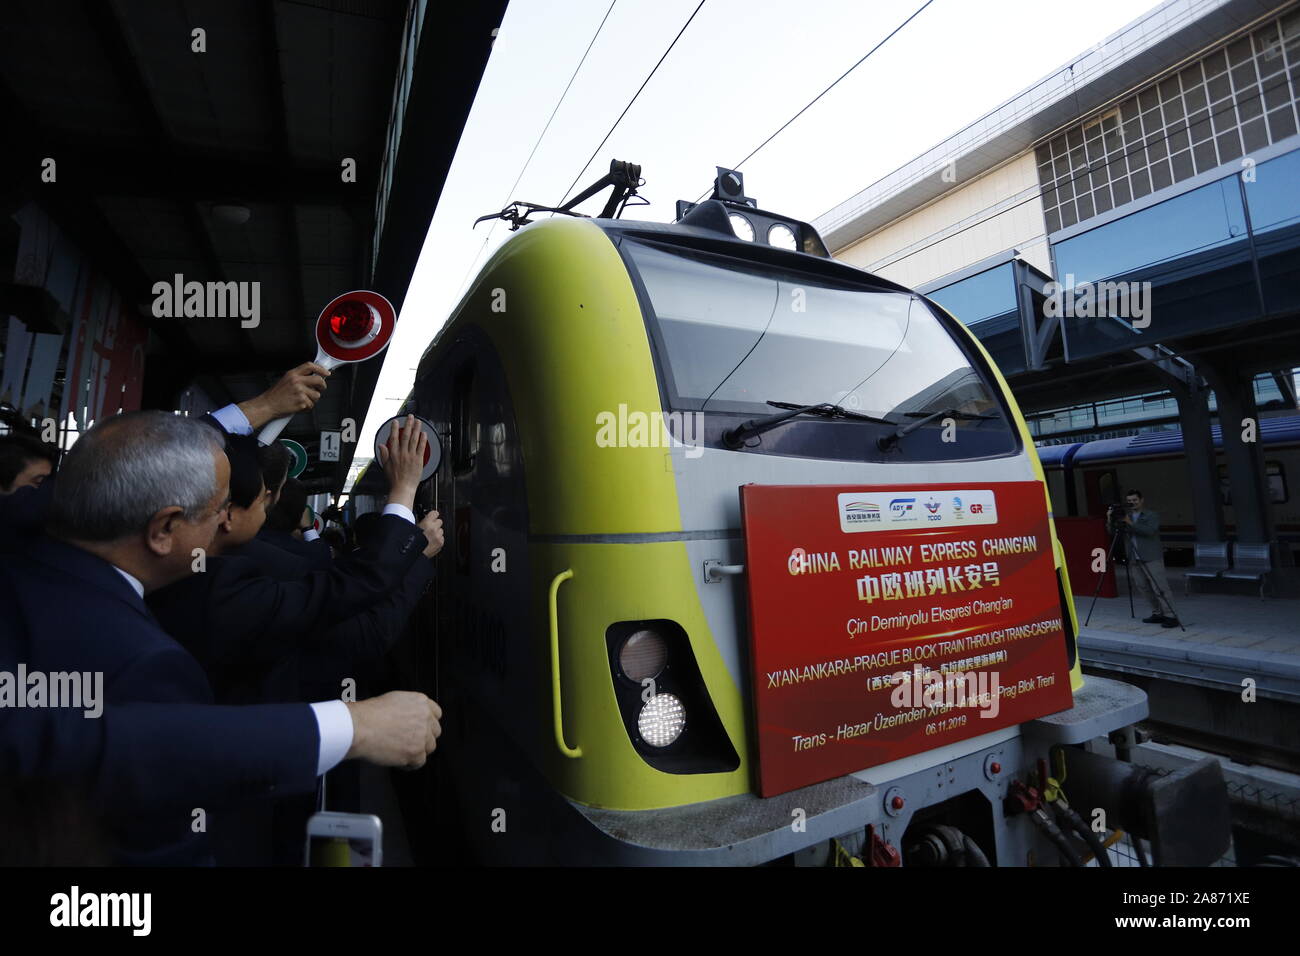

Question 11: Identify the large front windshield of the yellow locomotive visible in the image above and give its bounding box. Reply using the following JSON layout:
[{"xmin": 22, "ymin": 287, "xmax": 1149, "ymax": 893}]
[{"xmin": 623, "ymin": 241, "xmax": 1015, "ymax": 458}]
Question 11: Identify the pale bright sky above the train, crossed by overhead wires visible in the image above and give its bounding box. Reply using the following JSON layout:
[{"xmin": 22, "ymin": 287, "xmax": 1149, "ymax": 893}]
[{"xmin": 350, "ymin": 0, "xmax": 1154, "ymax": 494}]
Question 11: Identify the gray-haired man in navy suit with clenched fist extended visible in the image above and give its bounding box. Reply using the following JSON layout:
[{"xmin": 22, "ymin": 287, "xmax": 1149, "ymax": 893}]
[{"xmin": 0, "ymin": 412, "xmax": 441, "ymax": 862}]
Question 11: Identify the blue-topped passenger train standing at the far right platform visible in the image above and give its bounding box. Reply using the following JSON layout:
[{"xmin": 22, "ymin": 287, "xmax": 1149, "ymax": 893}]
[{"xmin": 1037, "ymin": 412, "xmax": 1300, "ymax": 564}]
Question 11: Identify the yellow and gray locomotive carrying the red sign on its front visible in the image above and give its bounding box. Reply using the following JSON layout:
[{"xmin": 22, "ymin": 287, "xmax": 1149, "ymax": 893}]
[{"xmin": 371, "ymin": 169, "xmax": 1226, "ymax": 866}]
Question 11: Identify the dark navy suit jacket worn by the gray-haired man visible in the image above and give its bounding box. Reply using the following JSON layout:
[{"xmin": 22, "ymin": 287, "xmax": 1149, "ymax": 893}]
[{"xmin": 0, "ymin": 537, "xmax": 320, "ymax": 865}]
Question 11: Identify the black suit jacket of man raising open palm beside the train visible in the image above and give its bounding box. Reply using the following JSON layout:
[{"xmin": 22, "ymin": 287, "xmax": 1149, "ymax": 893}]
[{"xmin": 150, "ymin": 515, "xmax": 428, "ymax": 702}]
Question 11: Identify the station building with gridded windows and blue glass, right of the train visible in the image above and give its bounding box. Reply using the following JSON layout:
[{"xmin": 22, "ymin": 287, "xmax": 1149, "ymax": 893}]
[{"xmin": 814, "ymin": 0, "xmax": 1300, "ymax": 571}]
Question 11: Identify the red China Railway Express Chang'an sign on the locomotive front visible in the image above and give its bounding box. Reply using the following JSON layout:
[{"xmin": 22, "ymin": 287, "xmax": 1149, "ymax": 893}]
[{"xmin": 740, "ymin": 481, "xmax": 1071, "ymax": 796}]
